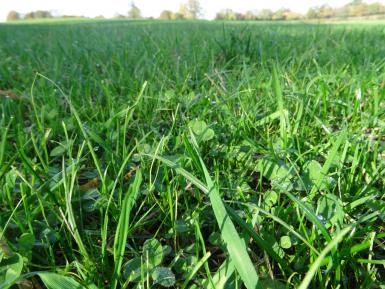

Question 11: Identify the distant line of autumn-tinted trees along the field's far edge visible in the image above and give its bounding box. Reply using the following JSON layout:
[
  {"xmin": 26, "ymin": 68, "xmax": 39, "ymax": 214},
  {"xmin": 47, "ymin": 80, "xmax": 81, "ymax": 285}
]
[{"xmin": 7, "ymin": 0, "xmax": 385, "ymax": 21}]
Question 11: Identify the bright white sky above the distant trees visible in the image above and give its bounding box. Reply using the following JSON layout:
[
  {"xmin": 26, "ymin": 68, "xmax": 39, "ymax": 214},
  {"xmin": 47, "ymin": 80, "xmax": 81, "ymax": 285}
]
[{"xmin": 0, "ymin": 0, "xmax": 385, "ymax": 21}]
